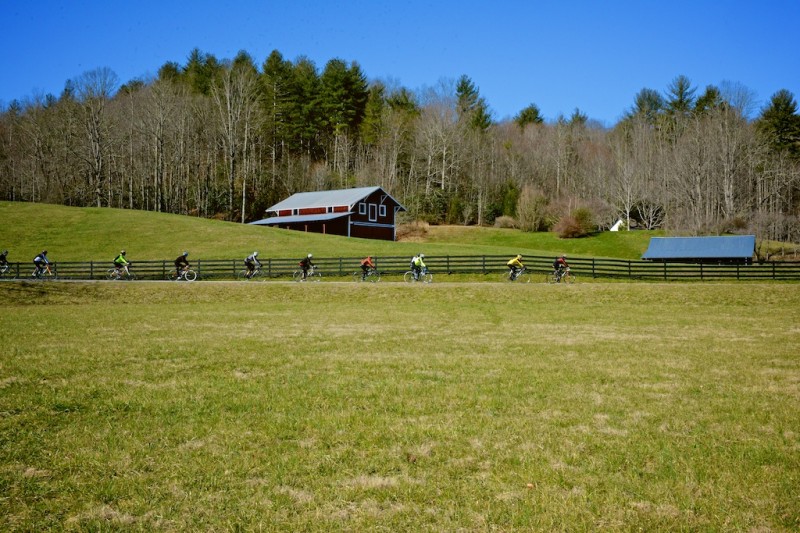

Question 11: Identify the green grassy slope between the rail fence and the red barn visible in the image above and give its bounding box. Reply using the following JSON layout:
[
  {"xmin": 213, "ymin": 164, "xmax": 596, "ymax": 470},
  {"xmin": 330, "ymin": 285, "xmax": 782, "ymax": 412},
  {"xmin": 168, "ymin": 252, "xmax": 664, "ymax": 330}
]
[{"xmin": 0, "ymin": 202, "xmax": 651, "ymax": 262}]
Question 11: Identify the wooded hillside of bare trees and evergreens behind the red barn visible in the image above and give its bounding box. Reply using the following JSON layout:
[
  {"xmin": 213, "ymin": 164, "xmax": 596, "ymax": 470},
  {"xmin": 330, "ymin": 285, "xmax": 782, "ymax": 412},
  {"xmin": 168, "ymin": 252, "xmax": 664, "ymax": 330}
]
[{"xmin": 0, "ymin": 50, "xmax": 800, "ymax": 241}]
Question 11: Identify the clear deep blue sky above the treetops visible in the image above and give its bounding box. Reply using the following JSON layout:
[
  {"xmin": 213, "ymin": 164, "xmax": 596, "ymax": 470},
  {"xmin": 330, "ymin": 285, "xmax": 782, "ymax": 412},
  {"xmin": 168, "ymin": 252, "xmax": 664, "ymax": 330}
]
[{"xmin": 0, "ymin": 0, "xmax": 800, "ymax": 125}]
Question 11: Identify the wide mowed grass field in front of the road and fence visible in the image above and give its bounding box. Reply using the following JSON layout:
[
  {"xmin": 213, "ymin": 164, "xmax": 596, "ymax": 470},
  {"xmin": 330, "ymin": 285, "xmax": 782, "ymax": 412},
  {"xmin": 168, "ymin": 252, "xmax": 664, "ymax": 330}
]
[{"xmin": 0, "ymin": 282, "xmax": 800, "ymax": 531}]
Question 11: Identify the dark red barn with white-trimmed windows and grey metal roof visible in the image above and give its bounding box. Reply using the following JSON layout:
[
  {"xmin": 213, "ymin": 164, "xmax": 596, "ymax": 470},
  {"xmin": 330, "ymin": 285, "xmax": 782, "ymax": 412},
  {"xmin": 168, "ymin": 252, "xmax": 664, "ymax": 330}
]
[{"xmin": 251, "ymin": 187, "xmax": 406, "ymax": 241}]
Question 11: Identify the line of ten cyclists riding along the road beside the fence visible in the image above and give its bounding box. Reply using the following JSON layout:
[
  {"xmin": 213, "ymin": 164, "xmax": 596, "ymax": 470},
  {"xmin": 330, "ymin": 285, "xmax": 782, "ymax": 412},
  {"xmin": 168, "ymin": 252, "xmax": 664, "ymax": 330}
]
[{"xmin": 0, "ymin": 246, "xmax": 569, "ymax": 282}]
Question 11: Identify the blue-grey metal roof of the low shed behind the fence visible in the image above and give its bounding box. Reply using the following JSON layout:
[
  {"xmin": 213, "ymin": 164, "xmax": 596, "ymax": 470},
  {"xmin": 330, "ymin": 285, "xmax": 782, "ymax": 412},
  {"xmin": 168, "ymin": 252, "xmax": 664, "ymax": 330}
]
[{"xmin": 642, "ymin": 235, "xmax": 756, "ymax": 259}]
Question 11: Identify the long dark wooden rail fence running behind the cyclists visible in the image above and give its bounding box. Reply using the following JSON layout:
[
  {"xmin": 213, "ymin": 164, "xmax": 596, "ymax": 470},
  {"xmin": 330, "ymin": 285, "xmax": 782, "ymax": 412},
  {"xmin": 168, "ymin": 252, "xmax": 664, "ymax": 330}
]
[{"xmin": 3, "ymin": 255, "xmax": 800, "ymax": 281}]
